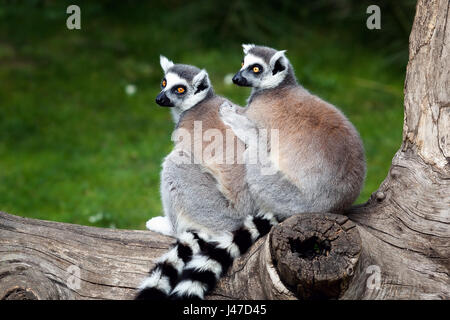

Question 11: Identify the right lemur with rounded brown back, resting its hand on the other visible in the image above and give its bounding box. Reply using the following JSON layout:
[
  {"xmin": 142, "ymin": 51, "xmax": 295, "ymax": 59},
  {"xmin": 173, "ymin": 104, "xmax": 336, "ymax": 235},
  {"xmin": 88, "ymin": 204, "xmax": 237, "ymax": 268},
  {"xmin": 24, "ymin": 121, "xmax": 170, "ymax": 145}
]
[{"xmin": 220, "ymin": 45, "xmax": 366, "ymax": 218}]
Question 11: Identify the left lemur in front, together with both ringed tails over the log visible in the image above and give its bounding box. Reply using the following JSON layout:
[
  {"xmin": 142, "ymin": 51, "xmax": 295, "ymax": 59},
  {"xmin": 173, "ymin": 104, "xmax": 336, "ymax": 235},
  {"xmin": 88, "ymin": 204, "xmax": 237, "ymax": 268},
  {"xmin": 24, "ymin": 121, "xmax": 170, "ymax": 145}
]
[{"xmin": 136, "ymin": 56, "xmax": 278, "ymax": 299}]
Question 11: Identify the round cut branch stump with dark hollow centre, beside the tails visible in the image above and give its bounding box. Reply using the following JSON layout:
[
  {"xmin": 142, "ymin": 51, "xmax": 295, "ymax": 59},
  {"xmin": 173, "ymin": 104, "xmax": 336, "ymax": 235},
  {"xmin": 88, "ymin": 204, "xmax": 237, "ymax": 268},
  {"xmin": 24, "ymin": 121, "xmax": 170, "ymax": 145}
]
[{"xmin": 270, "ymin": 213, "xmax": 361, "ymax": 300}]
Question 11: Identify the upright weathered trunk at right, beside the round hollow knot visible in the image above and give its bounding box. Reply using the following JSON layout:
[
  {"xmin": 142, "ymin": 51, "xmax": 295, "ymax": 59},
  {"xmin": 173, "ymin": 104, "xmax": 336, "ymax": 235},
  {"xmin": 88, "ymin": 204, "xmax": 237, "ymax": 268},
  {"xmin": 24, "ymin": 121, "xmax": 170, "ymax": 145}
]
[{"xmin": 343, "ymin": 0, "xmax": 450, "ymax": 299}]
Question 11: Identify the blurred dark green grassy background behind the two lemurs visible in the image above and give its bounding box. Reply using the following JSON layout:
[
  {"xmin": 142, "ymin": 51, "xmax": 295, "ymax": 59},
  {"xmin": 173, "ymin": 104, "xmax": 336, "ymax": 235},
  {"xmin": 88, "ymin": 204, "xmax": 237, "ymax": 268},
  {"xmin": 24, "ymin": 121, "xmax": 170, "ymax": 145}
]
[{"xmin": 0, "ymin": 0, "xmax": 415, "ymax": 229}]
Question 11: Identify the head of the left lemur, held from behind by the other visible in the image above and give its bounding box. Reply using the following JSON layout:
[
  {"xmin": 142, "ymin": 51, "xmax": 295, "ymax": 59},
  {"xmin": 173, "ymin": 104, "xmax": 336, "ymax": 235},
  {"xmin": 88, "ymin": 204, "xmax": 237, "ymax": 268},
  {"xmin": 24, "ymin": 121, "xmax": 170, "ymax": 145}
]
[{"xmin": 156, "ymin": 56, "xmax": 212, "ymax": 112}]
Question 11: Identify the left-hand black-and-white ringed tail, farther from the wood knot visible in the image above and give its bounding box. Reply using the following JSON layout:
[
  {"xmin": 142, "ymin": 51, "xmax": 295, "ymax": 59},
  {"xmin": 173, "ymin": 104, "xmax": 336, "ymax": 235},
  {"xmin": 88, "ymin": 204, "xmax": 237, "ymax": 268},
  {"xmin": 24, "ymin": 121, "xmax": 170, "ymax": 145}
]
[{"xmin": 135, "ymin": 231, "xmax": 200, "ymax": 300}]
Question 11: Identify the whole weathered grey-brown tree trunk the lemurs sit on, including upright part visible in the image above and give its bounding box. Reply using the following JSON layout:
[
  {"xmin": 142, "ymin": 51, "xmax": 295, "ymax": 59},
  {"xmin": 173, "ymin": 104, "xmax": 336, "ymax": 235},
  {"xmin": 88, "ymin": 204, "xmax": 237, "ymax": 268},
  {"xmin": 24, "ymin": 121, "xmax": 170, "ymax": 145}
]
[{"xmin": 0, "ymin": 0, "xmax": 450, "ymax": 299}]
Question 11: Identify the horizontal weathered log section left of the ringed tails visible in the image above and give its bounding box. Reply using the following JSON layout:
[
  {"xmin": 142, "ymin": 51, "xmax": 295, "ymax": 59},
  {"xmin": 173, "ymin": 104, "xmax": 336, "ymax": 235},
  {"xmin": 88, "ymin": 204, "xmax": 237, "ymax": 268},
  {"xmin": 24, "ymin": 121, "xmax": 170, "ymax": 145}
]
[{"xmin": 0, "ymin": 213, "xmax": 172, "ymax": 299}]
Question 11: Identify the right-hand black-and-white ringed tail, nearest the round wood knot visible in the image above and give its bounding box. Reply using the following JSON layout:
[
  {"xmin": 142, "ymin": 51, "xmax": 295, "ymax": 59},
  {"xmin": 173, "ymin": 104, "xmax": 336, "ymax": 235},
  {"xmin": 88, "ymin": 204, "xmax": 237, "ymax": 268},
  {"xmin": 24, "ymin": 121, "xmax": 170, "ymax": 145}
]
[{"xmin": 171, "ymin": 213, "xmax": 278, "ymax": 300}]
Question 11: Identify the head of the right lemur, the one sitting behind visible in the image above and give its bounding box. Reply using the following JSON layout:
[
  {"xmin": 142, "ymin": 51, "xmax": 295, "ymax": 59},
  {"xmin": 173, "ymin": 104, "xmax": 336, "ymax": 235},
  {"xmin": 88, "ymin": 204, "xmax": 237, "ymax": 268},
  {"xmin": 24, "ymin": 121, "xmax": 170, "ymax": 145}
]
[{"xmin": 233, "ymin": 44, "xmax": 296, "ymax": 89}]
